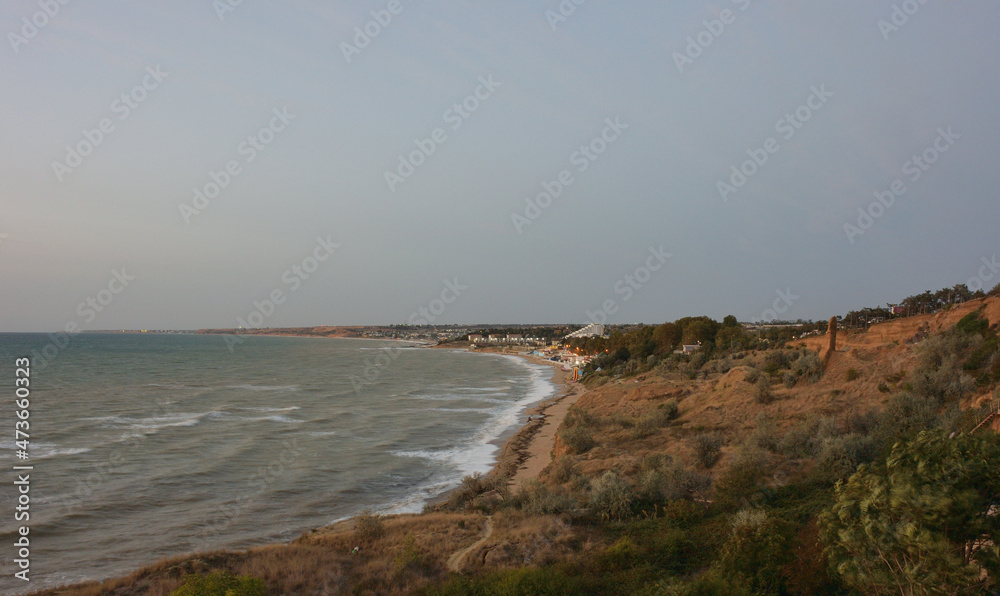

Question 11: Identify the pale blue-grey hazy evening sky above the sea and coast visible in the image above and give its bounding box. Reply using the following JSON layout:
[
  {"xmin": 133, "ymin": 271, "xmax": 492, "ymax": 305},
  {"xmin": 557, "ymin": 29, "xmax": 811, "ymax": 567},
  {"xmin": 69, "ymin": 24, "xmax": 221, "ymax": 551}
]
[{"xmin": 0, "ymin": 0, "xmax": 1000, "ymax": 332}]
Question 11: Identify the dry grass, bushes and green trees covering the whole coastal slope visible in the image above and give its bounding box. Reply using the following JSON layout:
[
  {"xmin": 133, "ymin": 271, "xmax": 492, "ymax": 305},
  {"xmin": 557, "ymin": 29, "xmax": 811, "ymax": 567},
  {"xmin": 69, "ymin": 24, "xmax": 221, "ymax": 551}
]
[{"xmin": 47, "ymin": 290, "xmax": 1000, "ymax": 596}]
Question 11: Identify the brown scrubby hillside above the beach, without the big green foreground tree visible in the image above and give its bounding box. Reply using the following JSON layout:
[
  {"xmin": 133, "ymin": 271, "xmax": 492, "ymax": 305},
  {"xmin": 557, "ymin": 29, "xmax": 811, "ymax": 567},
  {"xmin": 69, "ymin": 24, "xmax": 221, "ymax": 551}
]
[{"xmin": 33, "ymin": 297, "xmax": 1000, "ymax": 594}]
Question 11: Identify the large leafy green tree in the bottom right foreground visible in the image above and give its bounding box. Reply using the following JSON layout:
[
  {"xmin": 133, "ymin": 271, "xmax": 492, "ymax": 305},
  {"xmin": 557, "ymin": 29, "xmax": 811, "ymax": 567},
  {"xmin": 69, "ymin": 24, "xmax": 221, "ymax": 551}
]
[{"xmin": 820, "ymin": 430, "xmax": 1000, "ymax": 594}]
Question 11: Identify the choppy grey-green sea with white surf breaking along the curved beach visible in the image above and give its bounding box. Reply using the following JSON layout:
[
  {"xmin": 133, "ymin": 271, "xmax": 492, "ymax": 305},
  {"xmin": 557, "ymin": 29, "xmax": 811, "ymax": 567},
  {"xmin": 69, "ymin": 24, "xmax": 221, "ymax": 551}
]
[{"xmin": 0, "ymin": 333, "xmax": 554, "ymax": 594}]
